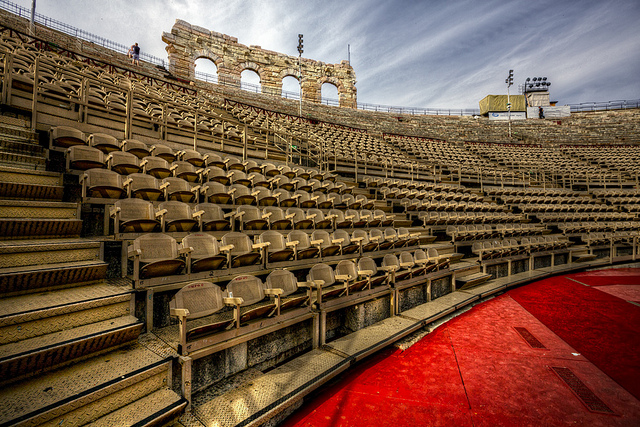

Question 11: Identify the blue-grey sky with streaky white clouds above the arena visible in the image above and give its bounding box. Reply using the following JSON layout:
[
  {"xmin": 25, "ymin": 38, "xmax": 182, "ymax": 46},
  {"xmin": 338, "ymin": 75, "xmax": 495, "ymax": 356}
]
[{"xmin": 12, "ymin": 0, "xmax": 640, "ymax": 108}]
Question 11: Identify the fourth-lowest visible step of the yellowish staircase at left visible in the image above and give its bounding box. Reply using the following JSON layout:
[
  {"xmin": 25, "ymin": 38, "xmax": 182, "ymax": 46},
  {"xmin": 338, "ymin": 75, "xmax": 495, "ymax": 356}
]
[{"xmin": 0, "ymin": 283, "xmax": 132, "ymax": 345}]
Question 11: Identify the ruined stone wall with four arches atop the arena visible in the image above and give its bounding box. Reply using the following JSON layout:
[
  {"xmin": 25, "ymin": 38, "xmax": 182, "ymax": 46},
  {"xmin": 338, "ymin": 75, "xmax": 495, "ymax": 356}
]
[{"xmin": 162, "ymin": 20, "xmax": 357, "ymax": 108}]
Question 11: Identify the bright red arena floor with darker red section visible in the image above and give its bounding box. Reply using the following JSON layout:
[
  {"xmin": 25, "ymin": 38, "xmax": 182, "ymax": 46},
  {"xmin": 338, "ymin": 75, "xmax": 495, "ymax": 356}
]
[{"xmin": 283, "ymin": 268, "xmax": 640, "ymax": 427}]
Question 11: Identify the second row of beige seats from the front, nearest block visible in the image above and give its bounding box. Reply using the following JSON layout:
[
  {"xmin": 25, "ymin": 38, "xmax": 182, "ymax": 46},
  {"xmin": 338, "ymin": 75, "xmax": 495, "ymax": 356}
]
[{"xmin": 128, "ymin": 229, "xmax": 430, "ymax": 280}]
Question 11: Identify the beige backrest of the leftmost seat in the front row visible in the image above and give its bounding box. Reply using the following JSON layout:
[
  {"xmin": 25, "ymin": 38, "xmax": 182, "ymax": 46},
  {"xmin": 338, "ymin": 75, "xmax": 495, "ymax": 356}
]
[{"xmin": 169, "ymin": 281, "xmax": 225, "ymax": 319}]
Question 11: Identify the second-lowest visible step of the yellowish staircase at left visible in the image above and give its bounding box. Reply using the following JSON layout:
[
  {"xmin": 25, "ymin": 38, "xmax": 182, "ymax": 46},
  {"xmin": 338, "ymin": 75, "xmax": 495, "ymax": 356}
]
[{"xmin": 0, "ymin": 344, "xmax": 175, "ymax": 426}]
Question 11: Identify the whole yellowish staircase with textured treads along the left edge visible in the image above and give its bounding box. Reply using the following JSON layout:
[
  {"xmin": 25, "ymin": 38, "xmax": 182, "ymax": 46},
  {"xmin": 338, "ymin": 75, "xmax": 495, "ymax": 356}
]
[{"xmin": 0, "ymin": 120, "xmax": 186, "ymax": 426}]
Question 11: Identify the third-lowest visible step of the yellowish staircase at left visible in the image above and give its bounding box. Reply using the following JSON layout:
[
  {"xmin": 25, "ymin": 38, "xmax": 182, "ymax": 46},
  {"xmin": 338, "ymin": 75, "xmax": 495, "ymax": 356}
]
[{"xmin": 0, "ymin": 315, "xmax": 143, "ymax": 382}]
